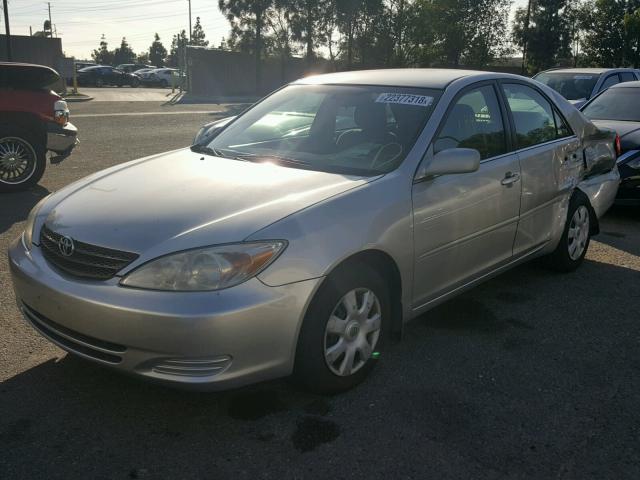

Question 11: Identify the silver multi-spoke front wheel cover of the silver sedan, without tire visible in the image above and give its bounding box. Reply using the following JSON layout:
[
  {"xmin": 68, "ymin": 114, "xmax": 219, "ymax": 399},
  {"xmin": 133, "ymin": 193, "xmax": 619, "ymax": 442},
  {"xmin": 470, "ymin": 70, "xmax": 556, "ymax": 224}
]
[{"xmin": 324, "ymin": 288, "xmax": 382, "ymax": 377}]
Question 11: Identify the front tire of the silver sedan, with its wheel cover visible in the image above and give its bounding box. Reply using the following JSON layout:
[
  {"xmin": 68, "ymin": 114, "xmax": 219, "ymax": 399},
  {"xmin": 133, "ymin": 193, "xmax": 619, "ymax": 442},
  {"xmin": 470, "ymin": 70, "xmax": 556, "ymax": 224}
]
[{"xmin": 293, "ymin": 264, "xmax": 391, "ymax": 394}]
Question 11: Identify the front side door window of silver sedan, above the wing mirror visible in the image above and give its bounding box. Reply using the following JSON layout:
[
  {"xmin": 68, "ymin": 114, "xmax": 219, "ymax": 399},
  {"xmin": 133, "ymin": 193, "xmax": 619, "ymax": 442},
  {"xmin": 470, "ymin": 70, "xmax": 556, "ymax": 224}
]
[{"xmin": 433, "ymin": 85, "xmax": 507, "ymax": 160}]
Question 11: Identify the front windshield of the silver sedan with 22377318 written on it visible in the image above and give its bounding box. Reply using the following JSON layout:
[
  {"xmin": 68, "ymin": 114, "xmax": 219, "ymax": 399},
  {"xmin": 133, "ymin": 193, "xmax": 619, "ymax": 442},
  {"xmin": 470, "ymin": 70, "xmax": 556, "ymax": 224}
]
[{"xmin": 204, "ymin": 85, "xmax": 440, "ymax": 176}]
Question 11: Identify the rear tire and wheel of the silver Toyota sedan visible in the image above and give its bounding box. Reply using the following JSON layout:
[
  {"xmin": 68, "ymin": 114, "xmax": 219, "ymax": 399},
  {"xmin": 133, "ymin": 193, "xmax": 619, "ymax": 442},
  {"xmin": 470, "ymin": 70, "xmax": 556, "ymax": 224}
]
[{"xmin": 545, "ymin": 192, "xmax": 591, "ymax": 273}]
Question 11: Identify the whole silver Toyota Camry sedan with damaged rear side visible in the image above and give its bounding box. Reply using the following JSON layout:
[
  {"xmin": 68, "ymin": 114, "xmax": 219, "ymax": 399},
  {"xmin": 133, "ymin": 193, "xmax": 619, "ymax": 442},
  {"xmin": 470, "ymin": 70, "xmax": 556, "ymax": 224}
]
[{"xmin": 9, "ymin": 70, "xmax": 619, "ymax": 392}]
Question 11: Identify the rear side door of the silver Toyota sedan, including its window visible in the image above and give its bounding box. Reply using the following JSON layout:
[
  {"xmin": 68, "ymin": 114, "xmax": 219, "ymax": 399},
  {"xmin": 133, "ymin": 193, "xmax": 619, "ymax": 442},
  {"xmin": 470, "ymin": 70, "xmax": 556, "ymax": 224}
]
[{"xmin": 501, "ymin": 80, "xmax": 582, "ymax": 256}]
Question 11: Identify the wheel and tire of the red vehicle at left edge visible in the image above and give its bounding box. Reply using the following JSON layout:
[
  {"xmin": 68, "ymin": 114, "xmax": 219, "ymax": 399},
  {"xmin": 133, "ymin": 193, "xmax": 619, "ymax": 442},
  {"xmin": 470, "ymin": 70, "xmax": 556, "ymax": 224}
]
[{"xmin": 0, "ymin": 125, "xmax": 47, "ymax": 192}]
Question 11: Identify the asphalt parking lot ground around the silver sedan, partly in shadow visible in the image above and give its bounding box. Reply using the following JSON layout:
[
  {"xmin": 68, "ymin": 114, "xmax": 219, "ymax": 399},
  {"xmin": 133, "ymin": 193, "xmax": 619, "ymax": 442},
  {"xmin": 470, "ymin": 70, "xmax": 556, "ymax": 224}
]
[{"xmin": 0, "ymin": 101, "xmax": 640, "ymax": 479}]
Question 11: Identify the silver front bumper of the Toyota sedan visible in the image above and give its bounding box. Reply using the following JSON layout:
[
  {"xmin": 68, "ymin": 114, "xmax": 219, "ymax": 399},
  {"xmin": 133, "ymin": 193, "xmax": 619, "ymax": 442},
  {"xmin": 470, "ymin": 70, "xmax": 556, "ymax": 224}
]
[{"xmin": 9, "ymin": 239, "xmax": 321, "ymax": 390}]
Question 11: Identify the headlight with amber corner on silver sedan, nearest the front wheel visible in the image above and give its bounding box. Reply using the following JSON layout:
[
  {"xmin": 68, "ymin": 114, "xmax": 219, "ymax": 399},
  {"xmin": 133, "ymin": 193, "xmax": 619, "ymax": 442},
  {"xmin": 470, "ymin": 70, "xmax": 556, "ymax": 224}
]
[{"xmin": 120, "ymin": 240, "xmax": 287, "ymax": 292}]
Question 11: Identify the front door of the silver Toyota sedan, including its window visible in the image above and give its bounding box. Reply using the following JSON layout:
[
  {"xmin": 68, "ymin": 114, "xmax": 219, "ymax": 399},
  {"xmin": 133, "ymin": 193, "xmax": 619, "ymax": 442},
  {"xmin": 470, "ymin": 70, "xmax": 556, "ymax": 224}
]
[{"xmin": 412, "ymin": 83, "xmax": 521, "ymax": 308}]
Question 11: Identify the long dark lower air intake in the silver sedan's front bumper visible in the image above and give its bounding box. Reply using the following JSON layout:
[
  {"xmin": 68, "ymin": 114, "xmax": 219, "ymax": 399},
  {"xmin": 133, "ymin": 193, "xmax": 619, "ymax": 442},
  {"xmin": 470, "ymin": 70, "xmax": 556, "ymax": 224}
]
[{"xmin": 22, "ymin": 303, "xmax": 127, "ymax": 364}]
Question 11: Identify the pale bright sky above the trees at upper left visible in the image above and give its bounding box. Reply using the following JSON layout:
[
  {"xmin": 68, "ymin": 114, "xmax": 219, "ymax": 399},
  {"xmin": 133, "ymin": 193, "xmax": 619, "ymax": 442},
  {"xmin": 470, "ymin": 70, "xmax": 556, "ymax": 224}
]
[{"xmin": 5, "ymin": 0, "xmax": 527, "ymax": 59}]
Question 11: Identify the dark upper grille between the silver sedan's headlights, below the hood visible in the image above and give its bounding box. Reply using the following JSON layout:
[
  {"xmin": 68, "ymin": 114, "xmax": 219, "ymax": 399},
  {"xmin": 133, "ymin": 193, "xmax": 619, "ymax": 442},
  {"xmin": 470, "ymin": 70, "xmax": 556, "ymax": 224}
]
[{"xmin": 40, "ymin": 225, "xmax": 138, "ymax": 280}]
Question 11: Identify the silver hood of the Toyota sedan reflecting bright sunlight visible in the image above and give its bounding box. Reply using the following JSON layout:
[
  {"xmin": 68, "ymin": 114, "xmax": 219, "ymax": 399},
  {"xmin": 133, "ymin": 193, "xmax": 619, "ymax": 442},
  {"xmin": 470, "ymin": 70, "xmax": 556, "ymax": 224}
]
[{"xmin": 46, "ymin": 149, "xmax": 372, "ymax": 260}]
